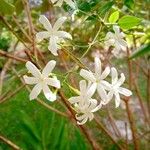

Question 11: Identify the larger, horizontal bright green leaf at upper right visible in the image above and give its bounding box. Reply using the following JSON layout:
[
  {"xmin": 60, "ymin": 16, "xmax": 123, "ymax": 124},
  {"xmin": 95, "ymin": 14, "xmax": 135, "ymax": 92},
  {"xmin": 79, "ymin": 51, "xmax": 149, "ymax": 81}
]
[{"xmin": 118, "ymin": 15, "xmax": 141, "ymax": 29}]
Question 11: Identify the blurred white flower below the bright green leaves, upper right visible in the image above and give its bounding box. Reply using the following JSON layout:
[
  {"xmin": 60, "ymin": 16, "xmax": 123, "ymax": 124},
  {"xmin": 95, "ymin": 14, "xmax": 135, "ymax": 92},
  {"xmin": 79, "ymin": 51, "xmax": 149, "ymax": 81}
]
[{"xmin": 105, "ymin": 25, "xmax": 128, "ymax": 54}]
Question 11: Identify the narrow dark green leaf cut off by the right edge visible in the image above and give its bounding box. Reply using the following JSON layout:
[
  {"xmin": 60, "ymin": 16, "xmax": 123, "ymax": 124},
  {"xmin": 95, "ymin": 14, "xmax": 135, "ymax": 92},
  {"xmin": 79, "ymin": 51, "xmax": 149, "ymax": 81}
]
[{"xmin": 130, "ymin": 43, "xmax": 150, "ymax": 59}]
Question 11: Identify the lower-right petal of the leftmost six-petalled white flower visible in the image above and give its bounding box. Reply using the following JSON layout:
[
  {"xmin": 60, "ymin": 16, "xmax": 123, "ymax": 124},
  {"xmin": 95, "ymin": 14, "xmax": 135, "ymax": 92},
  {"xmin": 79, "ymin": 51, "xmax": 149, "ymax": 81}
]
[{"xmin": 43, "ymin": 84, "xmax": 56, "ymax": 102}]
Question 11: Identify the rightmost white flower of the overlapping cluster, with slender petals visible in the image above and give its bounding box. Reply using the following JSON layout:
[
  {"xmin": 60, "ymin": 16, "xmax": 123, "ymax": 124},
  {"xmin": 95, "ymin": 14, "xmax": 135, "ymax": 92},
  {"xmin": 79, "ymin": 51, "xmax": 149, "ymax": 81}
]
[{"xmin": 107, "ymin": 68, "xmax": 132, "ymax": 108}]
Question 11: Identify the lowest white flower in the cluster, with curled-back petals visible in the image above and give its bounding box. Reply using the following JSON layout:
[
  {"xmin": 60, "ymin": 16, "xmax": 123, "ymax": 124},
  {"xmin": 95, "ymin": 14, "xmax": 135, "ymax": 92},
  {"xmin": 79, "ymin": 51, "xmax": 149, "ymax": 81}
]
[{"xmin": 76, "ymin": 99, "xmax": 102, "ymax": 125}]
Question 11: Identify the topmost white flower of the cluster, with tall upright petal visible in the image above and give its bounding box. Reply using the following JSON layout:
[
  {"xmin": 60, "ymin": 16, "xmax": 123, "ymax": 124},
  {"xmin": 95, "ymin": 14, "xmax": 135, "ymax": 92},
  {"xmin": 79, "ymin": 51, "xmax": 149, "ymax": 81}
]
[{"xmin": 80, "ymin": 57, "xmax": 110, "ymax": 104}]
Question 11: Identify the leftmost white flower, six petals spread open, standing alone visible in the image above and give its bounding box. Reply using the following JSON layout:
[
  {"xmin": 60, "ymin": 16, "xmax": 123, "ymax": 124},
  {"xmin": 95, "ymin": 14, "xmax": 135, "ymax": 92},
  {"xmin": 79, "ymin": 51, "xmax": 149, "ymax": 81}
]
[{"xmin": 23, "ymin": 60, "xmax": 60, "ymax": 101}]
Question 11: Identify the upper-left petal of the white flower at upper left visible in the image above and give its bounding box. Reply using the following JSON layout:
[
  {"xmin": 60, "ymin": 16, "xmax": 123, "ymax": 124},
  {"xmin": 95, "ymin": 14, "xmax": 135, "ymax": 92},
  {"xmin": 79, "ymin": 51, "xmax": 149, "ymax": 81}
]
[{"xmin": 39, "ymin": 15, "xmax": 52, "ymax": 32}]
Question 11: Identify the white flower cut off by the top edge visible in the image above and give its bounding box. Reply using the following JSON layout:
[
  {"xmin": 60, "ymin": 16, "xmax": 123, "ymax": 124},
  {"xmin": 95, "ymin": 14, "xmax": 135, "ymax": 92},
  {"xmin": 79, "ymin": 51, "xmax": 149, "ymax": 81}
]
[{"xmin": 51, "ymin": 0, "xmax": 75, "ymax": 9}]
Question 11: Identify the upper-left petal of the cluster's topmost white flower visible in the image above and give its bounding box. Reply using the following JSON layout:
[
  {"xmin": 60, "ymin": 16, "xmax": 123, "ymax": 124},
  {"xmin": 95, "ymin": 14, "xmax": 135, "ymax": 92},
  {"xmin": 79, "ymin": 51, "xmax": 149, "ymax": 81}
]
[{"xmin": 80, "ymin": 69, "xmax": 96, "ymax": 82}]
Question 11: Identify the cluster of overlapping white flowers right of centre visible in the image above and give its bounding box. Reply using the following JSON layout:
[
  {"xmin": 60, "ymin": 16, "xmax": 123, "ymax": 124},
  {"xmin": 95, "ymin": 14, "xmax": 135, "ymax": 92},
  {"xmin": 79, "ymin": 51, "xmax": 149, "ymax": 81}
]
[{"xmin": 69, "ymin": 58, "xmax": 132, "ymax": 125}]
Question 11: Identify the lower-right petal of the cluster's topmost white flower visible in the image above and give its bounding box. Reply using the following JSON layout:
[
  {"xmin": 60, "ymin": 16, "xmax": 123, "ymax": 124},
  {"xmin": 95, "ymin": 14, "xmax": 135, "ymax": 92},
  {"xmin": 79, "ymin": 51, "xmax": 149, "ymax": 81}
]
[{"xmin": 97, "ymin": 84, "xmax": 108, "ymax": 101}]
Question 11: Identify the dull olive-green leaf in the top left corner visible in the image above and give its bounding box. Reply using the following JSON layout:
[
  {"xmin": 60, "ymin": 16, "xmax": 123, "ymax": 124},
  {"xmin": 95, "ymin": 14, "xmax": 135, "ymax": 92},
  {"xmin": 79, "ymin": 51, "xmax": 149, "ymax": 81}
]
[{"xmin": 0, "ymin": 0, "xmax": 15, "ymax": 15}]
